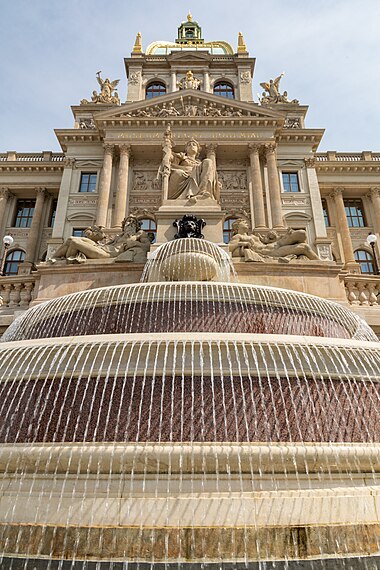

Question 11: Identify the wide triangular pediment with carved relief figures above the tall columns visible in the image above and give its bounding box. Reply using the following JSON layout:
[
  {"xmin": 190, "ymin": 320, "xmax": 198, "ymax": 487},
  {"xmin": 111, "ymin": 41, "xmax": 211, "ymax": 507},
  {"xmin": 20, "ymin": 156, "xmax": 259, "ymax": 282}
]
[{"xmin": 94, "ymin": 89, "xmax": 285, "ymax": 126}]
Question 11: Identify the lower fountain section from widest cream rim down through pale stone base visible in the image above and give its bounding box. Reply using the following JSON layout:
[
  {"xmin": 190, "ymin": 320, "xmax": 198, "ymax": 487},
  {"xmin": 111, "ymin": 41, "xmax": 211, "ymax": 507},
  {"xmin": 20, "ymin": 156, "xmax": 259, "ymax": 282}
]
[{"xmin": 0, "ymin": 333, "xmax": 380, "ymax": 568}]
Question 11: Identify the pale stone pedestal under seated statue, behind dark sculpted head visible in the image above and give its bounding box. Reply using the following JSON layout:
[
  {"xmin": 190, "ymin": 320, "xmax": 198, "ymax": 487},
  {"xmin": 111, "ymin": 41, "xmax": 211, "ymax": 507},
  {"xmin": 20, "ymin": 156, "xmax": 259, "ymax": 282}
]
[{"xmin": 156, "ymin": 199, "xmax": 224, "ymax": 245}]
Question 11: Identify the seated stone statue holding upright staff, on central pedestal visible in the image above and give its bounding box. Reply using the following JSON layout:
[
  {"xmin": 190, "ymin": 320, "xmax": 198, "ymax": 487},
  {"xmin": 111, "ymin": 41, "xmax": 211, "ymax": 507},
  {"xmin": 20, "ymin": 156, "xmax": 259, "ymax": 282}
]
[{"xmin": 159, "ymin": 128, "xmax": 219, "ymax": 203}]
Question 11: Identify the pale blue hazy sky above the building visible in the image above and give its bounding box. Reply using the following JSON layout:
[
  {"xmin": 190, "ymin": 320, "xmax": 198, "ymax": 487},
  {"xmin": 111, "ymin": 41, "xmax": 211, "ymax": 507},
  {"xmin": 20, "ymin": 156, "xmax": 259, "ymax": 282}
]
[{"xmin": 0, "ymin": 0, "xmax": 380, "ymax": 152}]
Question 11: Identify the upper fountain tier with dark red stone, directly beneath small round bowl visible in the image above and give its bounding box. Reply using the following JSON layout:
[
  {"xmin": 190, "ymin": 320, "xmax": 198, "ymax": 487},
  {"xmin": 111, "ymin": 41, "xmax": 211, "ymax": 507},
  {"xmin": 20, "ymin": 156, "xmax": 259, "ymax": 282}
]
[{"xmin": 3, "ymin": 282, "xmax": 376, "ymax": 341}]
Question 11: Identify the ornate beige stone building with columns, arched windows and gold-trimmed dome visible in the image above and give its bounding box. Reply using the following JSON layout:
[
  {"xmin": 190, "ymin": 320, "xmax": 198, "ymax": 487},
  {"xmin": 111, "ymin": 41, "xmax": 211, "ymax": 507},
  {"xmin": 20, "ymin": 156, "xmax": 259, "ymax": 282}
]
[{"xmin": 0, "ymin": 15, "xmax": 380, "ymax": 332}]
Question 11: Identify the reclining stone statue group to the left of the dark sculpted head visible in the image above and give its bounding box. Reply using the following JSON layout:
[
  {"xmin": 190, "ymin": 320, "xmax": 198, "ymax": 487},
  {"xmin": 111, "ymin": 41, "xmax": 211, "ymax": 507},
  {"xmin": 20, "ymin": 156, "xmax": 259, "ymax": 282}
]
[{"xmin": 48, "ymin": 216, "xmax": 151, "ymax": 263}]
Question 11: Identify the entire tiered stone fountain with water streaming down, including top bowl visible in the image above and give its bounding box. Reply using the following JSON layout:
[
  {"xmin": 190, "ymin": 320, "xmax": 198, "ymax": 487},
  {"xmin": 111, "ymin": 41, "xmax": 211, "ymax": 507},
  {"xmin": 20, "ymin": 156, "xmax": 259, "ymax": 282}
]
[{"xmin": 0, "ymin": 238, "xmax": 380, "ymax": 570}]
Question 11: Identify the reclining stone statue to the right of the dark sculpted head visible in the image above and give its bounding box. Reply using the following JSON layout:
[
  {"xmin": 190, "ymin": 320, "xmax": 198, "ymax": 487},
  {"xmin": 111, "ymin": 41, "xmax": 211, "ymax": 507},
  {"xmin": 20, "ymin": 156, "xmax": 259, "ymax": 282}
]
[{"xmin": 229, "ymin": 218, "xmax": 319, "ymax": 263}]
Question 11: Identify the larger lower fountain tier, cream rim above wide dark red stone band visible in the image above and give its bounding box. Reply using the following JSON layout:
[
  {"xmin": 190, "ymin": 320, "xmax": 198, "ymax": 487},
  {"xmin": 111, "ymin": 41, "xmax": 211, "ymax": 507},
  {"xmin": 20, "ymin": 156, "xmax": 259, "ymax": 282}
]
[{"xmin": 0, "ymin": 333, "xmax": 380, "ymax": 444}]
